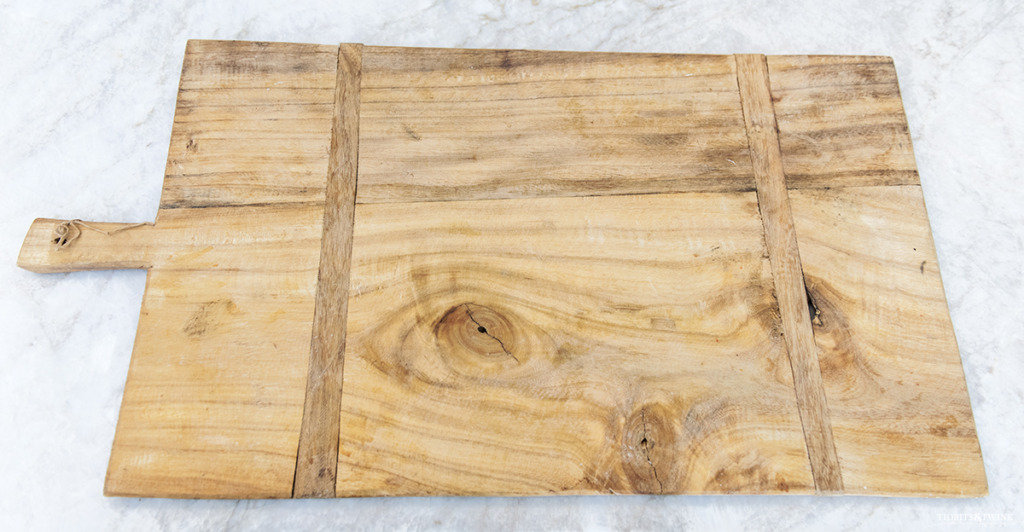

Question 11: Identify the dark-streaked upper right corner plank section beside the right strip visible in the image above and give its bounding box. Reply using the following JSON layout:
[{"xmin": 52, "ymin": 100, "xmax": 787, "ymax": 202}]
[{"xmin": 768, "ymin": 55, "xmax": 919, "ymax": 188}]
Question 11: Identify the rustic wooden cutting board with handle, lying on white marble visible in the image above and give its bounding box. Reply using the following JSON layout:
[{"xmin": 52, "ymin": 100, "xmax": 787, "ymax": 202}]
[{"xmin": 18, "ymin": 41, "xmax": 987, "ymax": 498}]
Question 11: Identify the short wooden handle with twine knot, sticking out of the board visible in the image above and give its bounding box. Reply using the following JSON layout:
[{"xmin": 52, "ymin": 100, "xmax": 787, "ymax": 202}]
[{"xmin": 17, "ymin": 218, "xmax": 155, "ymax": 273}]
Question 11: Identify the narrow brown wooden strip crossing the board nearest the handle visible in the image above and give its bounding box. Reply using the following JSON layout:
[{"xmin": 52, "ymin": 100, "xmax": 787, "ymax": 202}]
[{"xmin": 292, "ymin": 44, "xmax": 362, "ymax": 497}]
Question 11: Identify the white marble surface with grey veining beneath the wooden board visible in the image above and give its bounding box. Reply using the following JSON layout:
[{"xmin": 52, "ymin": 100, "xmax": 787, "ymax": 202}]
[{"xmin": 0, "ymin": 0, "xmax": 1024, "ymax": 530}]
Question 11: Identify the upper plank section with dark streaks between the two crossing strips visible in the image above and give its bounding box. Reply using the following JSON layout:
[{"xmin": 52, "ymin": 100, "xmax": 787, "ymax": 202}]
[{"xmin": 357, "ymin": 47, "xmax": 754, "ymax": 203}]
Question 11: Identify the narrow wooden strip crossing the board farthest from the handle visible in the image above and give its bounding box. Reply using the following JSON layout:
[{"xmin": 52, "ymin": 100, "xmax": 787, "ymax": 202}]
[{"xmin": 735, "ymin": 54, "xmax": 843, "ymax": 493}]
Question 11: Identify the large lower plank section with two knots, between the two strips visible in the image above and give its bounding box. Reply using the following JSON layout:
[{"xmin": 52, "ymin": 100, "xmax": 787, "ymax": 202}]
[{"xmin": 337, "ymin": 193, "xmax": 813, "ymax": 496}]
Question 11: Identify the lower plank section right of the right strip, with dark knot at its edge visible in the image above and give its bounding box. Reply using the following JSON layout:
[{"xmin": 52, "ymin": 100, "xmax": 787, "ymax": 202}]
[{"xmin": 790, "ymin": 186, "xmax": 987, "ymax": 496}]
